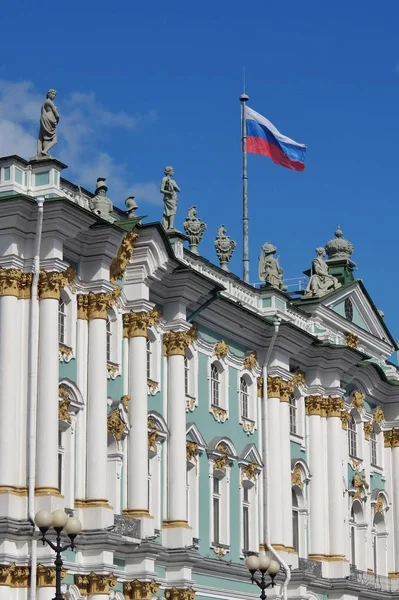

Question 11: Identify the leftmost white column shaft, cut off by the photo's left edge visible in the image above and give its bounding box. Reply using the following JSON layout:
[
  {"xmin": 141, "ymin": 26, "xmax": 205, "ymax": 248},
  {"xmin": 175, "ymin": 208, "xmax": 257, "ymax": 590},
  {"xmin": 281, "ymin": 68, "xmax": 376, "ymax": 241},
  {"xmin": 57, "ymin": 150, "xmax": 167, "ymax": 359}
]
[{"xmin": 0, "ymin": 288, "xmax": 19, "ymax": 490}]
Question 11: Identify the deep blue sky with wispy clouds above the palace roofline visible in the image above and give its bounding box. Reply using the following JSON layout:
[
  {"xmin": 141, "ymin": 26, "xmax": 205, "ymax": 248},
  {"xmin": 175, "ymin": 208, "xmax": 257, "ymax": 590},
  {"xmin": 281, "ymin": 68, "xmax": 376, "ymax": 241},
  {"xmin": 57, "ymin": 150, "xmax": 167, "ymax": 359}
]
[{"xmin": 0, "ymin": 0, "xmax": 399, "ymax": 337}]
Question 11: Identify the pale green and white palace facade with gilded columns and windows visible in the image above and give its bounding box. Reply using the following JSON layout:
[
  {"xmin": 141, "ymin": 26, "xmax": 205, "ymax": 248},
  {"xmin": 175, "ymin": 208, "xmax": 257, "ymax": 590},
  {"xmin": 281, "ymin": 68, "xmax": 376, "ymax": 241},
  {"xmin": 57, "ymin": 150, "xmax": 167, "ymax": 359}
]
[{"xmin": 0, "ymin": 156, "xmax": 399, "ymax": 600}]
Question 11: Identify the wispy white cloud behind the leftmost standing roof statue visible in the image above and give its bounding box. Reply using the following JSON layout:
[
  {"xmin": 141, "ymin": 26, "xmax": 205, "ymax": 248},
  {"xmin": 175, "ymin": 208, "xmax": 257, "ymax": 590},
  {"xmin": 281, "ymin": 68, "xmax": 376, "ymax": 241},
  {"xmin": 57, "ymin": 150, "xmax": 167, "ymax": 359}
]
[{"xmin": 0, "ymin": 80, "xmax": 162, "ymax": 206}]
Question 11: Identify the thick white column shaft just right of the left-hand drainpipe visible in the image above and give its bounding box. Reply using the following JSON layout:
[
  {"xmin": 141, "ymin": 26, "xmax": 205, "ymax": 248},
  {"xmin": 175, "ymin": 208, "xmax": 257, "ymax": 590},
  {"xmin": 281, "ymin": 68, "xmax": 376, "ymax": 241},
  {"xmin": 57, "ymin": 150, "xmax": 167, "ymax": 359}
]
[{"xmin": 36, "ymin": 292, "xmax": 59, "ymax": 495}]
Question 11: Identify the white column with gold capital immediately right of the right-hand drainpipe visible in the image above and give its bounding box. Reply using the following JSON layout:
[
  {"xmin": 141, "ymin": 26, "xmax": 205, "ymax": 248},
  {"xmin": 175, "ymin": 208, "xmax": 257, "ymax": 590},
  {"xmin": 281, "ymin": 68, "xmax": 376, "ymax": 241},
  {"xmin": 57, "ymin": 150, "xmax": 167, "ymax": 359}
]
[{"xmin": 266, "ymin": 377, "xmax": 282, "ymax": 550}]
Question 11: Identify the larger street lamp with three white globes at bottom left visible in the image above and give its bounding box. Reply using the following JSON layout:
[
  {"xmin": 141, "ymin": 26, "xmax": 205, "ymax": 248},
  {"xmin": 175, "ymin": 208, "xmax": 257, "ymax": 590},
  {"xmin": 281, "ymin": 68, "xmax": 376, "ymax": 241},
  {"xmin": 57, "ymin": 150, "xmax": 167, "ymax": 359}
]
[{"xmin": 35, "ymin": 510, "xmax": 82, "ymax": 600}]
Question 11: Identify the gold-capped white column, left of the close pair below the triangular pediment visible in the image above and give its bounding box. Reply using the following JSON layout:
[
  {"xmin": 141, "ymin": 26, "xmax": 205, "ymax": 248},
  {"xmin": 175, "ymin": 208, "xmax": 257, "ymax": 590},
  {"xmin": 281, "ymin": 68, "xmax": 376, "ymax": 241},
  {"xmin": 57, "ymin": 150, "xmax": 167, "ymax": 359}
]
[{"xmin": 306, "ymin": 396, "xmax": 327, "ymax": 560}]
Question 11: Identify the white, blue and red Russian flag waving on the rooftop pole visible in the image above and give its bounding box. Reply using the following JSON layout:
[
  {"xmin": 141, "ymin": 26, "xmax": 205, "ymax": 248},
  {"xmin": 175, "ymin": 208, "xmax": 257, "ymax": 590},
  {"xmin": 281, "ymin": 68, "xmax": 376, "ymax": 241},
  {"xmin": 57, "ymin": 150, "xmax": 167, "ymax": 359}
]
[{"xmin": 245, "ymin": 106, "xmax": 306, "ymax": 171}]
